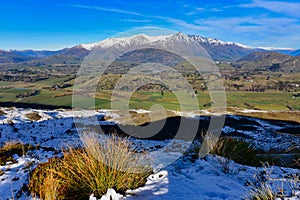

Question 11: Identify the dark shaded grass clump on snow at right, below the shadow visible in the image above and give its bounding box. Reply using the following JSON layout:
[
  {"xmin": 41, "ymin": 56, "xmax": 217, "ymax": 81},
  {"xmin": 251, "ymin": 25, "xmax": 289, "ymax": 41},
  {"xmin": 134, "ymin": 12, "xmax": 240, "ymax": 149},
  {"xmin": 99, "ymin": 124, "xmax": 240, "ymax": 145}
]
[{"xmin": 211, "ymin": 137, "xmax": 260, "ymax": 166}]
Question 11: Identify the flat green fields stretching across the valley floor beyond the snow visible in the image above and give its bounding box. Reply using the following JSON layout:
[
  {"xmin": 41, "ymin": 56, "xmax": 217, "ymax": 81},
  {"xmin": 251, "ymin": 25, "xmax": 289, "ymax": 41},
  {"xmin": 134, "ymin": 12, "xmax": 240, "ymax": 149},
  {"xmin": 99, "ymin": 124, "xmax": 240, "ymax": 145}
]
[{"xmin": 0, "ymin": 71, "xmax": 300, "ymax": 110}]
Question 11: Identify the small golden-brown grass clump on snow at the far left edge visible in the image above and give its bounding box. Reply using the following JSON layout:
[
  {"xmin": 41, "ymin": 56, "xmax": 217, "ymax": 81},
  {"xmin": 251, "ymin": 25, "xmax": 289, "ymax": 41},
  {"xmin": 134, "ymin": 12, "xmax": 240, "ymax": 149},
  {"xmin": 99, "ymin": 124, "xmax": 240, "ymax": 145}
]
[{"xmin": 0, "ymin": 142, "xmax": 33, "ymax": 165}]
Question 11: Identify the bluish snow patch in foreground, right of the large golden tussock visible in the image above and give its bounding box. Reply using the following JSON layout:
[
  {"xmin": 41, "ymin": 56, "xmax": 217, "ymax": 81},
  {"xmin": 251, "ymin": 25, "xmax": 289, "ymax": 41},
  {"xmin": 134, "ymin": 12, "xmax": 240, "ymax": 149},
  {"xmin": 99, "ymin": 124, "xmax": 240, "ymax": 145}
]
[{"xmin": 126, "ymin": 155, "xmax": 300, "ymax": 200}]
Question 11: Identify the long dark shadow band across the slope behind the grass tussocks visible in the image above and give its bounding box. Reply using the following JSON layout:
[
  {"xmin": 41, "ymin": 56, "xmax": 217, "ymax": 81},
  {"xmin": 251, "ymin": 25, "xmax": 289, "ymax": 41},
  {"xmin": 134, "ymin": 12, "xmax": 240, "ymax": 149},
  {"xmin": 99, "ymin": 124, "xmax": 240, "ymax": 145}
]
[{"xmin": 88, "ymin": 115, "xmax": 300, "ymax": 140}]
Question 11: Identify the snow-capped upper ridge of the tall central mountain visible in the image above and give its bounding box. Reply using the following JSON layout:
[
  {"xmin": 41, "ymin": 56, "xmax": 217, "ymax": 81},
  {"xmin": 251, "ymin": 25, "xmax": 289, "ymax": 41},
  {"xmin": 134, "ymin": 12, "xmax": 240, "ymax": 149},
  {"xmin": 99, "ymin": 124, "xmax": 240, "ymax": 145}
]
[{"xmin": 78, "ymin": 32, "xmax": 265, "ymax": 61}]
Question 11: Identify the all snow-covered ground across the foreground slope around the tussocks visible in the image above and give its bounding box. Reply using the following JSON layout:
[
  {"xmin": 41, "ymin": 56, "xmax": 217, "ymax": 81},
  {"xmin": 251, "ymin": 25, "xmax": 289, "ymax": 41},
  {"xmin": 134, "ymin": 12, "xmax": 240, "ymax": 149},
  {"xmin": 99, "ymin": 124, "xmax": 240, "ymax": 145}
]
[{"xmin": 0, "ymin": 108, "xmax": 300, "ymax": 200}]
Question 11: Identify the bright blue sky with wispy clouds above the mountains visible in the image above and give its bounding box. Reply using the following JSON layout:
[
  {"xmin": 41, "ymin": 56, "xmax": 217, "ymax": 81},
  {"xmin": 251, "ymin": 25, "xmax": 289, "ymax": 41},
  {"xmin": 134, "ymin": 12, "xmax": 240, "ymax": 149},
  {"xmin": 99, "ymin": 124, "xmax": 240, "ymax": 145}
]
[{"xmin": 0, "ymin": 0, "xmax": 300, "ymax": 49}]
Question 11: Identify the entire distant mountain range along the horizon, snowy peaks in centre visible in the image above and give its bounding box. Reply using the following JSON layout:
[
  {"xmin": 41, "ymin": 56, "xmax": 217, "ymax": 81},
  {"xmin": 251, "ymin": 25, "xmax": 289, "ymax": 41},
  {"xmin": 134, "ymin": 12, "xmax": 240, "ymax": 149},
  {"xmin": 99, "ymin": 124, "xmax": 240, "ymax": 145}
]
[{"xmin": 0, "ymin": 33, "xmax": 300, "ymax": 68}]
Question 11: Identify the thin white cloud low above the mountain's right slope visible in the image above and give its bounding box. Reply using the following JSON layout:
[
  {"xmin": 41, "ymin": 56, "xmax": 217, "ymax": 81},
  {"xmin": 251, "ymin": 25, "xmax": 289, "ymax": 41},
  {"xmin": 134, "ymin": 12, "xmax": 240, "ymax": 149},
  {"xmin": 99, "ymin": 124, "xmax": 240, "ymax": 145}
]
[{"xmin": 195, "ymin": 16, "xmax": 300, "ymax": 47}]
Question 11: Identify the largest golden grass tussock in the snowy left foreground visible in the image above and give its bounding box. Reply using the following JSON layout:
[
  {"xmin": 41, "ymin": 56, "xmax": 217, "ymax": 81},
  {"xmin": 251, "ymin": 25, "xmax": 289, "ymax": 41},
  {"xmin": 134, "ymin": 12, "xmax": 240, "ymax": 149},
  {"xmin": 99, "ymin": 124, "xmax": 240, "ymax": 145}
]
[{"xmin": 29, "ymin": 134, "xmax": 152, "ymax": 199}]
